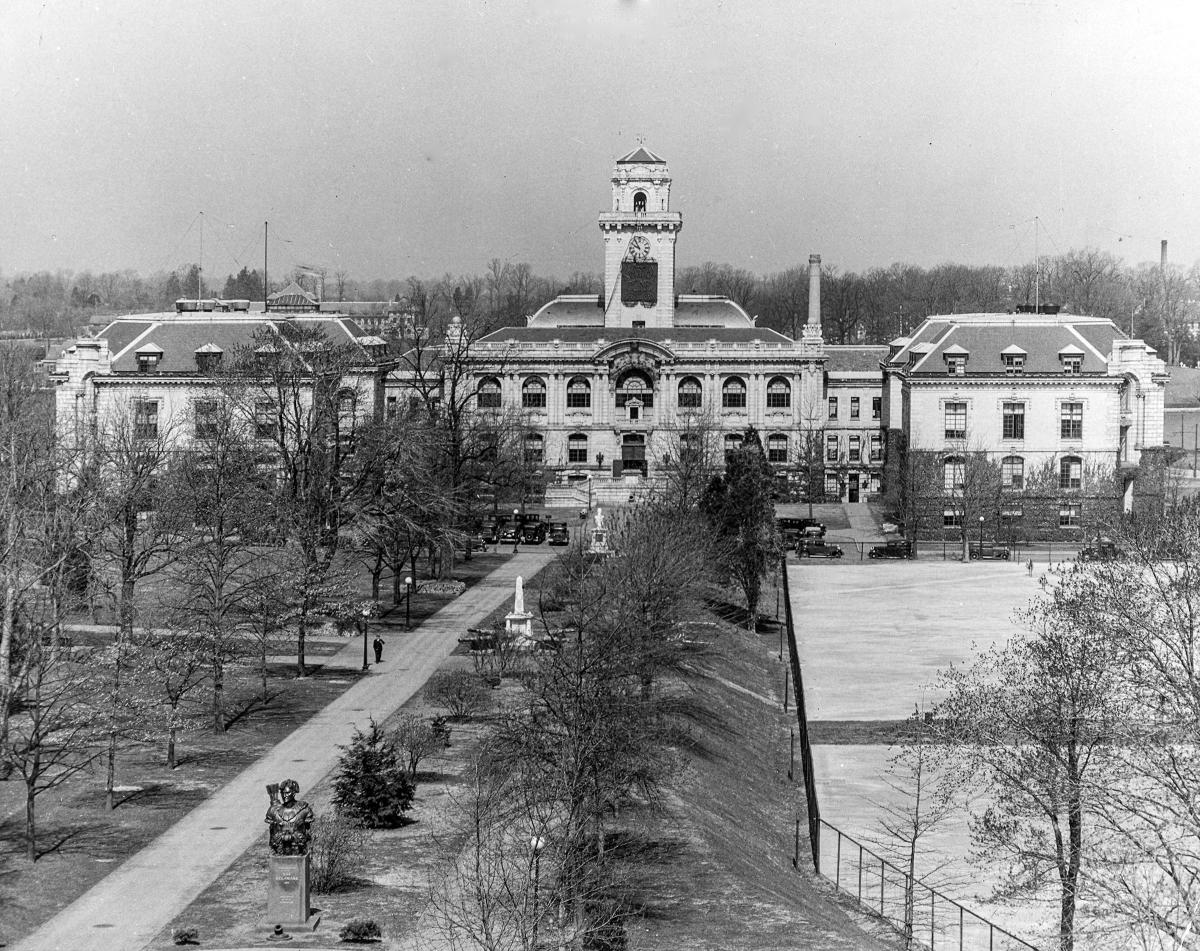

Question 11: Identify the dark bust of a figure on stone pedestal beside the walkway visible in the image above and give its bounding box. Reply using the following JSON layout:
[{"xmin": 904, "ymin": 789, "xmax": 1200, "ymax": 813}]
[{"xmin": 265, "ymin": 779, "xmax": 320, "ymax": 931}]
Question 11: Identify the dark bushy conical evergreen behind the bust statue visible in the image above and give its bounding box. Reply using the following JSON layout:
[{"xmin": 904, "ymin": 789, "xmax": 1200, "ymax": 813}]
[{"xmin": 334, "ymin": 718, "xmax": 416, "ymax": 829}]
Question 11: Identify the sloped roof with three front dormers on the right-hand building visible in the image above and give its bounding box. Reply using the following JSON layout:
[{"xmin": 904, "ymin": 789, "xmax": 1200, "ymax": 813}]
[{"xmin": 892, "ymin": 313, "xmax": 1124, "ymax": 376}]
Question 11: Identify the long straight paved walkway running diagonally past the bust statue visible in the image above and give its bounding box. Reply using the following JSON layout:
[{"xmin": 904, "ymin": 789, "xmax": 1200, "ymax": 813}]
[{"xmin": 14, "ymin": 551, "xmax": 553, "ymax": 951}]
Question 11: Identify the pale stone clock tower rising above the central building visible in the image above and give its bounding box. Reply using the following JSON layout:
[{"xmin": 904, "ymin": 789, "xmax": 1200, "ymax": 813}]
[{"xmin": 600, "ymin": 145, "xmax": 683, "ymax": 328}]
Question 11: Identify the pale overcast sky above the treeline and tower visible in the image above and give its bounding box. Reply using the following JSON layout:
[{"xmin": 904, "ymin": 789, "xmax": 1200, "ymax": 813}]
[{"xmin": 0, "ymin": 0, "xmax": 1200, "ymax": 279}]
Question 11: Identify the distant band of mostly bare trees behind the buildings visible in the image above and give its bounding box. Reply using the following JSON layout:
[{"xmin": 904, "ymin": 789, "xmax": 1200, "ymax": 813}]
[{"xmin": 0, "ymin": 247, "xmax": 1200, "ymax": 363}]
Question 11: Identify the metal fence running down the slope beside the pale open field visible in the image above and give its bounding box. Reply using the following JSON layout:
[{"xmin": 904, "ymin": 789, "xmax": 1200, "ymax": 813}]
[{"xmin": 780, "ymin": 558, "xmax": 1039, "ymax": 951}]
